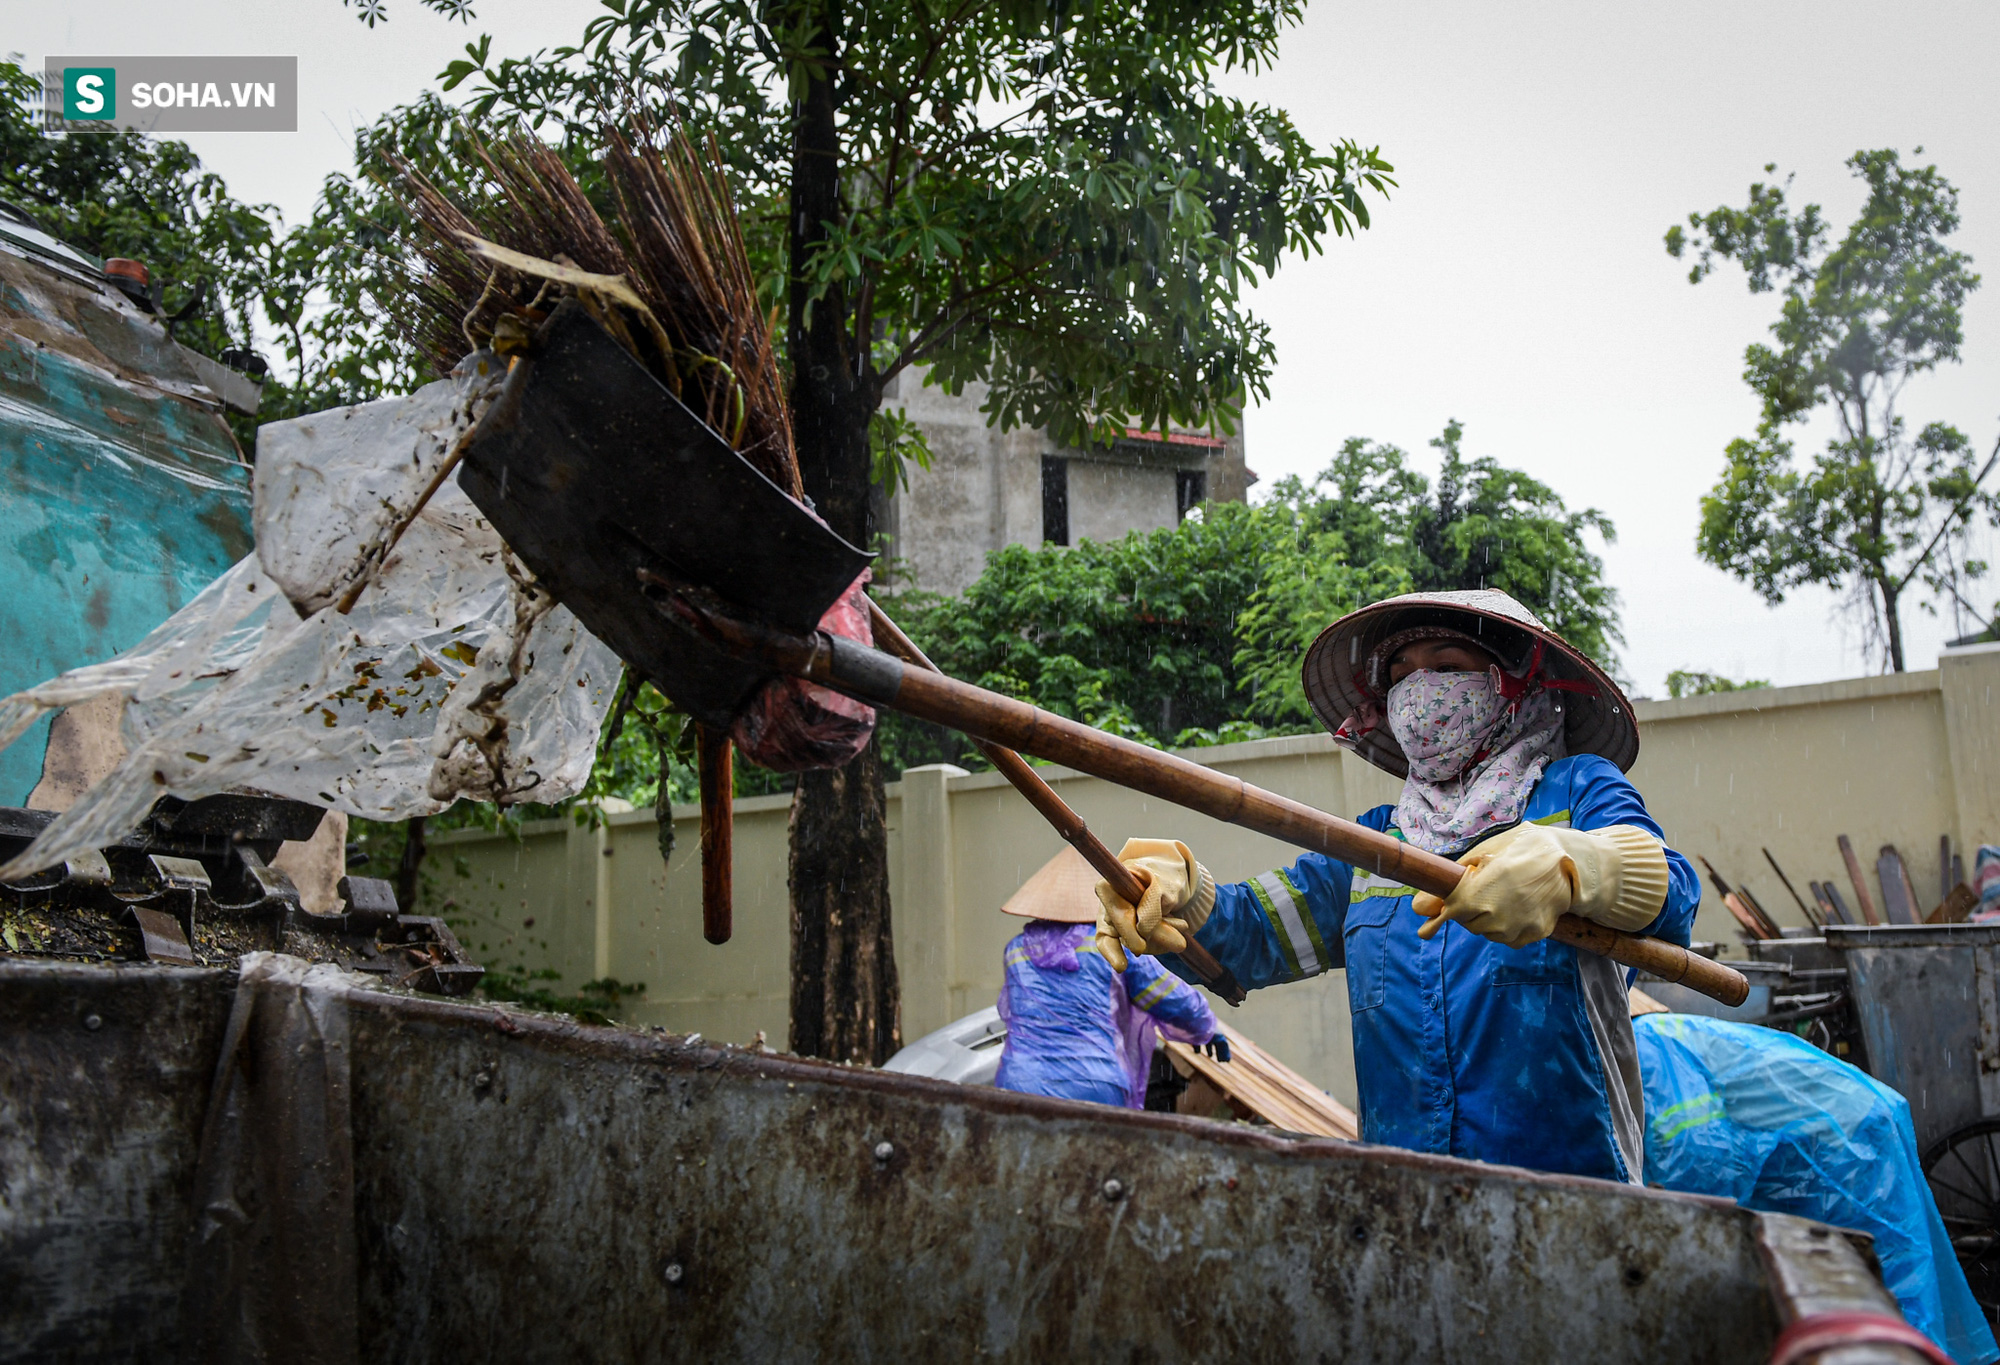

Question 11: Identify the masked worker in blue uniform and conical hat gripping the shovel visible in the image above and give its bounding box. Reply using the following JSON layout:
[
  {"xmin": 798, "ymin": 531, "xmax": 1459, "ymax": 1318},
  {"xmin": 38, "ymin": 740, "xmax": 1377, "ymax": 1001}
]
[{"xmin": 1096, "ymin": 590, "xmax": 1700, "ymax": 1183}]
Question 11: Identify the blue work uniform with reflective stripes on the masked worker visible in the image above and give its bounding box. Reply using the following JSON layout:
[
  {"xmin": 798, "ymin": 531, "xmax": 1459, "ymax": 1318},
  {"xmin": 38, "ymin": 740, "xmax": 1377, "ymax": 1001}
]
[{"xmin": 1164, "ymin": 755, "xmax": 1702, "ymax": 1181}]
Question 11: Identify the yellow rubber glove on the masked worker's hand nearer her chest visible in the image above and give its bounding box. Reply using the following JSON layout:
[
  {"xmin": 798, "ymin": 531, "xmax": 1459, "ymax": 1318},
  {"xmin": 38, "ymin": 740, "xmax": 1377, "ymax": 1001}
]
[{"xmin": 1412, "ymin": 825, "xmax": 1666, "ymax": 949}]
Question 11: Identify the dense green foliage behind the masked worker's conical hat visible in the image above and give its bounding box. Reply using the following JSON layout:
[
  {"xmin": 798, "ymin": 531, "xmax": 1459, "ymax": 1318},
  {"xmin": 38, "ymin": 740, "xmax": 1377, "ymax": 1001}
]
[{"xmin": 886, "ymin": 422, "xmax": 1620, "ymax": 767}]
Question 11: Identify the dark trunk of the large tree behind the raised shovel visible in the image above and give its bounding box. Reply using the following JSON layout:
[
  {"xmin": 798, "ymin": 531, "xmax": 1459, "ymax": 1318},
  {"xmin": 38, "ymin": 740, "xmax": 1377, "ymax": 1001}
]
[{"xmin": 786, "ymin": 6, "xmax": 902, "ymax": 1063}]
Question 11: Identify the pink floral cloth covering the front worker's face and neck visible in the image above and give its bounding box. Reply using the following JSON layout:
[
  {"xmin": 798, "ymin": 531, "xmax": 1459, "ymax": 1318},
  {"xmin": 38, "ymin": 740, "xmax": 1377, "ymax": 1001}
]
[{"xmin": 1384, "ymin": 668, "xmax": 1564, "ymax": 857}]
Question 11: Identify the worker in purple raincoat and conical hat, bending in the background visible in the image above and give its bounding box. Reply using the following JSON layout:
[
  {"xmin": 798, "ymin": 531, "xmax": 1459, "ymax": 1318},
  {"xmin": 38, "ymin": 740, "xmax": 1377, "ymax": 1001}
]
[{"xmin": 994, "ymin": 849, "xmax": 1228, "ymax": 1109}]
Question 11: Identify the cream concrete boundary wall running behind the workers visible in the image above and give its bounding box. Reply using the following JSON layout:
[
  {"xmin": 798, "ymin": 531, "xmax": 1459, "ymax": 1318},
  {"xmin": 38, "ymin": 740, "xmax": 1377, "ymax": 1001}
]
[{"xmin": 432, "ymin": 646, "xmax": 2000, "ymax": 1103}]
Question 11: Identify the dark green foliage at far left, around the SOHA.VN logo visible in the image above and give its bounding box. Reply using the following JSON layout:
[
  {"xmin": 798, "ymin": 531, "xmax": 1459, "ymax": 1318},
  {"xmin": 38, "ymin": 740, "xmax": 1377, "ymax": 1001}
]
[{"xmin": 0, "ymin": 58, "xmax": 278, "ymax": 366}]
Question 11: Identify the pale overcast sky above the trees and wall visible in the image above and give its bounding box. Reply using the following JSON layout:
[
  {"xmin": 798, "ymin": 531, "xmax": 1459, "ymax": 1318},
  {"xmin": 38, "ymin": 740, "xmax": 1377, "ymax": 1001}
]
[{"xmin": 19, "ymin": 0, "xmax": 2000, "ymax": 695}]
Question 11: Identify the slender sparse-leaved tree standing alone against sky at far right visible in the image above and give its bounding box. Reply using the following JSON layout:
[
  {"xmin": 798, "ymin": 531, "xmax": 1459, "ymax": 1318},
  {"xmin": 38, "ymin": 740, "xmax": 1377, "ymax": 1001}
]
[{"xmin": 1666, "ymin": 148, "xmax": 2000, "ymax": 672}]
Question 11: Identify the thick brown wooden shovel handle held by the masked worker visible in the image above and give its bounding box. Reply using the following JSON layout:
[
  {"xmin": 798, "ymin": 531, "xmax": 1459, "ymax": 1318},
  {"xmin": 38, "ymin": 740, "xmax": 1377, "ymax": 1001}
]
[{"xmin": 668, "ymin": 598, "xmax": 1750, "ymax": 1005}]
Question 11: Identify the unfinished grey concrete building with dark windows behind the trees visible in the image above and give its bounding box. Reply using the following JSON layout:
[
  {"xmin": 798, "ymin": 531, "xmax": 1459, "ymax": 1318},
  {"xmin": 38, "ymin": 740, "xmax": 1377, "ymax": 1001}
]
[{"xmin": 878, "ymin": 370, "xmax": 1256, "ymax": 592}]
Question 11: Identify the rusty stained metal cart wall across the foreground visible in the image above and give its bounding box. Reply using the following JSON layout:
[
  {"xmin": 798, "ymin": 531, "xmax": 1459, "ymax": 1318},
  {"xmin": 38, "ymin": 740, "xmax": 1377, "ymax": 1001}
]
[{"xmin": 0, "ymin": 959, "xmax": 1916, "ymax": 1365}]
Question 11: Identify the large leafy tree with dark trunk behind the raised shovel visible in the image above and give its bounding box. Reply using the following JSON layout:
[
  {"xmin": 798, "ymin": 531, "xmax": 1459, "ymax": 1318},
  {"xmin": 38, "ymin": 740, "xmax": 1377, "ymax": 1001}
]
[{"xmin": 448, "ymin": 0, "xmax": 1390, "ymax": 1061}]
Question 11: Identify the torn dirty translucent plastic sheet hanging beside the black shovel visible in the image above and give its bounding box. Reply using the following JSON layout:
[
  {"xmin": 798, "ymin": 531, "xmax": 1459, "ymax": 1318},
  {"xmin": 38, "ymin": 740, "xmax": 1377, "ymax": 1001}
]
[{"xmin": 0, "ymin": 356, "xmax": 620, "ymax": 879}]
